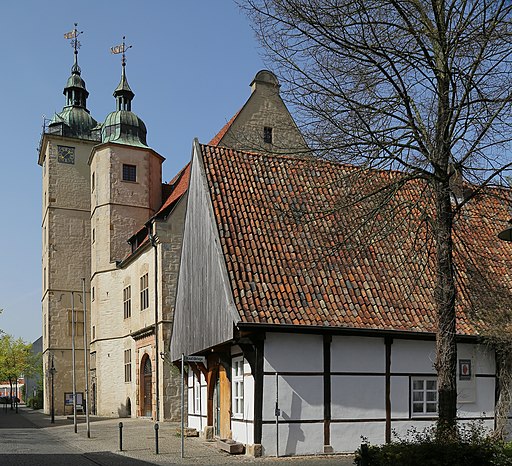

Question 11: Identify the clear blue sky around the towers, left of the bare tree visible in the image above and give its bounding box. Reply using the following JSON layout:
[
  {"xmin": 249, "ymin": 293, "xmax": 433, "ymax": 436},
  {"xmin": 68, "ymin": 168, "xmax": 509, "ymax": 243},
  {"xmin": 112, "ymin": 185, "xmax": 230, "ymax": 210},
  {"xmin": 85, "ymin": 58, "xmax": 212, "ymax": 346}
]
[{"xmin": 0, "ymin": 0, "xmax": 266, "ymax": 341}]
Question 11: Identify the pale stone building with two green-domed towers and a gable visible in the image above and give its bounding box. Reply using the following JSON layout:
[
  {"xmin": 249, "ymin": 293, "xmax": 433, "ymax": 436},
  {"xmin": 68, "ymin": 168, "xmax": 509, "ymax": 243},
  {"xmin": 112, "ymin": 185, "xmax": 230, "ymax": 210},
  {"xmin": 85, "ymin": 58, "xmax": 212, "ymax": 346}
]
[{"xmin": 39, "ymin": 41, "xmax": 306, "ymax": 420}]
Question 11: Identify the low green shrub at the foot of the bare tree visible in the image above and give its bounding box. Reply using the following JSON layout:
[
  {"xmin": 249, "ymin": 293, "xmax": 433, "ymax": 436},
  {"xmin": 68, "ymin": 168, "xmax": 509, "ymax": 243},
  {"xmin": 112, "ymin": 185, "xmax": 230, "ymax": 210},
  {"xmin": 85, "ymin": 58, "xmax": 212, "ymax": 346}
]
[{"xmin": 355, "ymin": 422, "xmax": 512, "ymax": 466}]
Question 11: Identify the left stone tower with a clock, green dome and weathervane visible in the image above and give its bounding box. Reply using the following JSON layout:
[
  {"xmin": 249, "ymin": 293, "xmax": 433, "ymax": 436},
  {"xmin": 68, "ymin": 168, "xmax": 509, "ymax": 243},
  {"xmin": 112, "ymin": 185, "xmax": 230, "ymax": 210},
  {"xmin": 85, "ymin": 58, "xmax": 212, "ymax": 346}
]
[{"xmin": 38, "ymin": 25, "xmax": 98, "ymax": 415}]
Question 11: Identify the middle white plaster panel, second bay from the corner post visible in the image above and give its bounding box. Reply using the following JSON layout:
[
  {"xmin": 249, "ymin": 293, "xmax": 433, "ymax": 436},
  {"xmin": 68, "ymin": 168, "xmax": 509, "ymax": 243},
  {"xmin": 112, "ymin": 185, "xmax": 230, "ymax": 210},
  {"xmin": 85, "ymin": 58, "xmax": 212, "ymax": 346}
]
[{"xmin": 332, "ymin": 375, "xmax": 386, "ymax": 419}]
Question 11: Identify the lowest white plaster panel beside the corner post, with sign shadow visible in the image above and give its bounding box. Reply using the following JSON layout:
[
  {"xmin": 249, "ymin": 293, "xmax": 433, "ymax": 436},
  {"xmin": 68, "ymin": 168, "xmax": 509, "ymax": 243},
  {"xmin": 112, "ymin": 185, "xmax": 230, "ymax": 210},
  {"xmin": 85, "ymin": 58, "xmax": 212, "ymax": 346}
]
[{"xmin": 261, "ymin": 422, "xmax": 324, "ymax": 456}]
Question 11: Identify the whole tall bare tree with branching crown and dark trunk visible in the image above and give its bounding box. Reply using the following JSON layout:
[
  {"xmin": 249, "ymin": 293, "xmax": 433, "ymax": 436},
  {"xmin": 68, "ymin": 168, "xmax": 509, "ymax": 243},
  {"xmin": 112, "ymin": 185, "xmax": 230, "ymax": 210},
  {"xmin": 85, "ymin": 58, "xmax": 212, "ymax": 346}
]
[{"xmin": 242, "ymin": 0, "xmax": 512, "ymax": 433}]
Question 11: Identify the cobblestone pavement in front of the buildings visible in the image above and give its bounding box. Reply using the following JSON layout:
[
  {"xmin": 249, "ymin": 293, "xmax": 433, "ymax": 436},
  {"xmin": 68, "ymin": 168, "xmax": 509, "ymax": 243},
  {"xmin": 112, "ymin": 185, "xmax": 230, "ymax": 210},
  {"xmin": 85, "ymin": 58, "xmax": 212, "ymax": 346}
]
[{"xmin": 0, "ymin": 407, "xmax": 353, "ymax": 466}]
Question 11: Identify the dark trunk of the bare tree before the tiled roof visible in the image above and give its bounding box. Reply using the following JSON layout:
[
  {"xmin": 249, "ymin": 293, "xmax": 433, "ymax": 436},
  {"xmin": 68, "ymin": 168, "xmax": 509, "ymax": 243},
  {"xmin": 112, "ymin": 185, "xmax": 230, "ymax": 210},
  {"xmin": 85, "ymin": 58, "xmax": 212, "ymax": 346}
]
[{"xmin": 435, "ymin": 177, "xmax": 457, "ymax": 436}]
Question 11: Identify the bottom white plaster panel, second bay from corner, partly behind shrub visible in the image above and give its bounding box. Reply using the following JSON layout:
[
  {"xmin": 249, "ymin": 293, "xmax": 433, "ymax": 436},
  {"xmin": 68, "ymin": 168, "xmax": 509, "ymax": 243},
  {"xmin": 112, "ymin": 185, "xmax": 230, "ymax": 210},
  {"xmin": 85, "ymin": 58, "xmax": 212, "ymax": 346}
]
[{"xmin": 331, "ymin": 422, "xmax": 385, "ymax": 453}]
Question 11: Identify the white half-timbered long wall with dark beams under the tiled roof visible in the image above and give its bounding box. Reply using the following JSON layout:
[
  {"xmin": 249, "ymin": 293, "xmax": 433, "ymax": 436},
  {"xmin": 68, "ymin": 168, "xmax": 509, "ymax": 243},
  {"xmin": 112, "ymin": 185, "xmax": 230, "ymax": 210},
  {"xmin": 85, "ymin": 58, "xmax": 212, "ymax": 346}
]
[{"xmin": 262, "ymin": 333, "xmax": 495, "ymax": 455}]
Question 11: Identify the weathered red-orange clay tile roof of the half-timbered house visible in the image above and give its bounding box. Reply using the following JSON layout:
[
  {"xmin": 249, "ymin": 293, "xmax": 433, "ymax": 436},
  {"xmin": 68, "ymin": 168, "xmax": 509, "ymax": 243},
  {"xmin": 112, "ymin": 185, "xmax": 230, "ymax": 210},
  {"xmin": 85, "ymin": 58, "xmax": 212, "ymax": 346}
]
[{"xmin": 201, "ymin": 145, "xmax": 512, "ymax": 335}]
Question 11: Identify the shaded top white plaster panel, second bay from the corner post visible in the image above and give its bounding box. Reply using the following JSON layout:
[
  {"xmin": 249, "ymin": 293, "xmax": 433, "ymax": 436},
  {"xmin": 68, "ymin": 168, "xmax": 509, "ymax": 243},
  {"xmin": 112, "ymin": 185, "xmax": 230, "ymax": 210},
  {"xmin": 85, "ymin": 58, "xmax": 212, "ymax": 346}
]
[{"xmin": 331, "ymin": 336, "xmax": 386, "ymax": 372}]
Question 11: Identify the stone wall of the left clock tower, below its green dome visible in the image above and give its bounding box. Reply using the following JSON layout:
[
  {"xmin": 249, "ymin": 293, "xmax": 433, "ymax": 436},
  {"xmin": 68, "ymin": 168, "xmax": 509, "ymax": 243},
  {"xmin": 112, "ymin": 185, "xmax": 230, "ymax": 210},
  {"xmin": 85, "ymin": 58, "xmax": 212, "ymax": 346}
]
[{"xmin": 40, "ymin": 135, "xmax": 94, "ymax": 415}]
